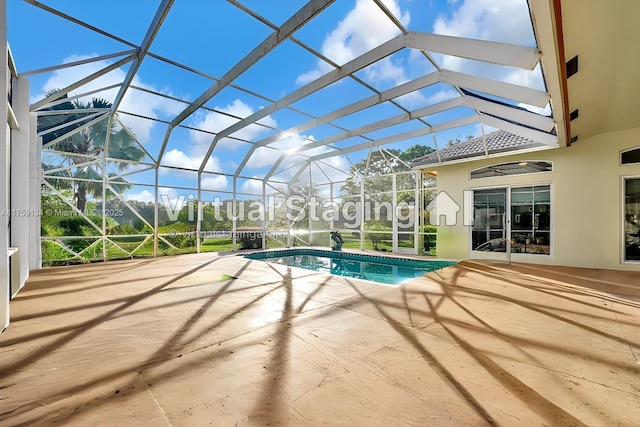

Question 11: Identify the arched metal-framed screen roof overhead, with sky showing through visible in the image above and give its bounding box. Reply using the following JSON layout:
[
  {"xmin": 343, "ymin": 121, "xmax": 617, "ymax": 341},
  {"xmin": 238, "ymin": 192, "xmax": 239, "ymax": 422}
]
[{"xmin": 7, "ymin": 0, "xmax": 558, "ymax": 189}]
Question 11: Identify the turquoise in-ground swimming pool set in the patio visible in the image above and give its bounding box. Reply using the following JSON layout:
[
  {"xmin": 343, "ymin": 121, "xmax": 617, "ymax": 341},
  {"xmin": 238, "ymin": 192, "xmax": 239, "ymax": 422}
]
[{"xmin": 244, "ymin": 249, "xmax": 455, "ymax": 285}]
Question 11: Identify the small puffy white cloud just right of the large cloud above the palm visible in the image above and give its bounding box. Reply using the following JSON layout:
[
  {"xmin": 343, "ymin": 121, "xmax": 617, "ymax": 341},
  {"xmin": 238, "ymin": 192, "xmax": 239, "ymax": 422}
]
[{"xmin": 189, "ymin": 99, "xmax": 276, "ymax": 150}]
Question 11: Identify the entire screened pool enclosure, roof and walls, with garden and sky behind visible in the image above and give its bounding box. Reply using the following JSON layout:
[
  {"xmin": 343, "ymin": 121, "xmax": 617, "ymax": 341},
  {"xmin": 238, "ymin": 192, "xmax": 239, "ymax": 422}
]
[{"xmin": 7, "ymin": 0, "xmax": 566, "ymax": 266}]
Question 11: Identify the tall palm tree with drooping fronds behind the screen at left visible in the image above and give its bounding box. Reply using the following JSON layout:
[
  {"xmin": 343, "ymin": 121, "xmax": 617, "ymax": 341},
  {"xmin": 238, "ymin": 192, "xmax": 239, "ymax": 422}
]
[{"xmin": 38, "ymin": 90, "xmax": 145, "ymax": 212}]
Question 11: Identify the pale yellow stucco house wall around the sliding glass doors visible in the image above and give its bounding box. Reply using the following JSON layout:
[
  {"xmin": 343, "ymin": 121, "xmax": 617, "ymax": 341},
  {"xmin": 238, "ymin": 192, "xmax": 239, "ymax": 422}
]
[{"xmin": 430, "ymin": 127, "xmax": 640, "ymax": 270}]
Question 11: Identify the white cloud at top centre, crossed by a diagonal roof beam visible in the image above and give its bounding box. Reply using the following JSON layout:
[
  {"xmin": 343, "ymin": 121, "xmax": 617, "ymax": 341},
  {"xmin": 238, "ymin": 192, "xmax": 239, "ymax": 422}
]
[{"xmin": 296, "ymin": 0, "xmax": 410, "ymax": 85}]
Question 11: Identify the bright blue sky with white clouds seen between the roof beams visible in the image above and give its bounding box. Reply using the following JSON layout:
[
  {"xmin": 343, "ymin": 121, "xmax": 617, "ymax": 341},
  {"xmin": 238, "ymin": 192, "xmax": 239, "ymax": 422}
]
[{"xmin": 7, "ymin": 0, "xmax": 549, "ymax": 201}]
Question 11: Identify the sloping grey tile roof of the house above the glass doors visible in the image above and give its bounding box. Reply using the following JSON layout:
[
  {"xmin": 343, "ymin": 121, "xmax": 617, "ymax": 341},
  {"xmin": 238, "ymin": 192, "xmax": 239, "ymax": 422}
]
[{"xmin": 411, "ymin": 130, "xmax": 543, "ymax": 166}]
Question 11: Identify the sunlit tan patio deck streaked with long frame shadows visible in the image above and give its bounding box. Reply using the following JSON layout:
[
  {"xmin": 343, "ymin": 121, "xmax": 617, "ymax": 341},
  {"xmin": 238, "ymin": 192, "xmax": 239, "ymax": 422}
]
[{"xmin": 0, "ymin": 254, "xmax": 640, "ymax": 426}]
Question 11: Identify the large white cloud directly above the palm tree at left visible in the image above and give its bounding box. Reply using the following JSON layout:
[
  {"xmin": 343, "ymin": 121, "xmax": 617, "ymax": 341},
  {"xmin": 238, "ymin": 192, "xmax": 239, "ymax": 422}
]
[{"xmin": 31, "ymin": 54, "xmax": 184, "ymax": 143}]
